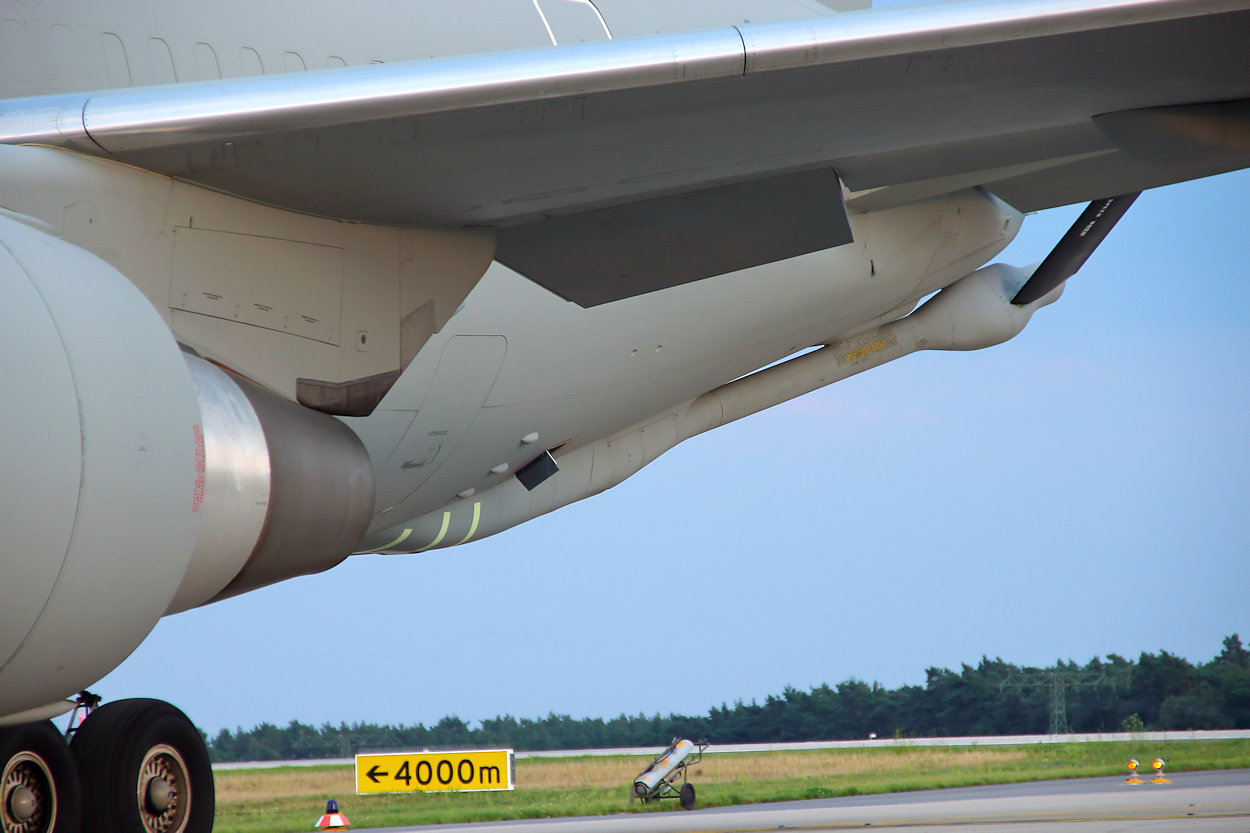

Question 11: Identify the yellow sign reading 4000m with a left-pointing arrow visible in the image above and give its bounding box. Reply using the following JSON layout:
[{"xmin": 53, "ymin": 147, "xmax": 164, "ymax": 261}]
[{"xmin": 356, "ymin": 749, "xmax": 516, "ymax": 795}]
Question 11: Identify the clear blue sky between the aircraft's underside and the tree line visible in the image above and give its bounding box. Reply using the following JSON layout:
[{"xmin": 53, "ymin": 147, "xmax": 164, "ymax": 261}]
[{"xmin": 95, "ymin": 167, "xmax": 1250, "ymax": 733}]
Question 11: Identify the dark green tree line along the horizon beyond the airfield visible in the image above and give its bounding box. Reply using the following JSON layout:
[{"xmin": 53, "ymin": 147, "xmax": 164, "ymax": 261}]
[{"xmin": 209, "ymin": 634, "xmax": 1250, "ymax": 762}]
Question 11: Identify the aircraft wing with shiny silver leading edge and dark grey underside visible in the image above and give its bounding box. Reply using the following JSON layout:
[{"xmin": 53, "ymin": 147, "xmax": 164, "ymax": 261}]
[{"xmin": 0, "ymin": 0, "xmax": 1250, "ymax": 305}]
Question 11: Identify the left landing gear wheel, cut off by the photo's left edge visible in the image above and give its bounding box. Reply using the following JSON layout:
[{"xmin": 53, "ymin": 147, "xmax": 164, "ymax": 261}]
[{"xmin": 0, "ymin": 720, "xmax": 81, "ymax": 833}]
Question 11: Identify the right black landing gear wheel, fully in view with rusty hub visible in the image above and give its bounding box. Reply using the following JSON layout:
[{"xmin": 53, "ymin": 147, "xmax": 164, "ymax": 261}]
[{"xmin": 71, "ymin": 699, "xmax": 215, "ymax": 833}]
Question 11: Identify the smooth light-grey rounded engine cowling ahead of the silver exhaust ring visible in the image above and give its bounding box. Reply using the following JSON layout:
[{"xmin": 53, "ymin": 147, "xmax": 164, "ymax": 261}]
[{"xmin": 0, "ymin": 216, "xmax": 199, "ymax": 715}]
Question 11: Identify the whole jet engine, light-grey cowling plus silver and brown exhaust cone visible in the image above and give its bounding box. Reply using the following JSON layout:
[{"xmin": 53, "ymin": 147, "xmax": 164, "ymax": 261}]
[{"xmin": 0, "ymin": 214, "xmax": 374, "ymax": 718}]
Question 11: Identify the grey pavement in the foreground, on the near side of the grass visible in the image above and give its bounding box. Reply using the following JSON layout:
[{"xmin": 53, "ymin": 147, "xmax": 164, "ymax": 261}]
[{"xmin": 354, "ymin": 769, "xmax": 1250, "ymax": 833}]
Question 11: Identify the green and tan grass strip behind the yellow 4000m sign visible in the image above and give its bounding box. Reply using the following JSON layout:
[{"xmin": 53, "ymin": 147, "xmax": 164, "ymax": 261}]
[{"xmin": 214, "ymin": 740, "xmax": 1250, "ymax": 833}]
